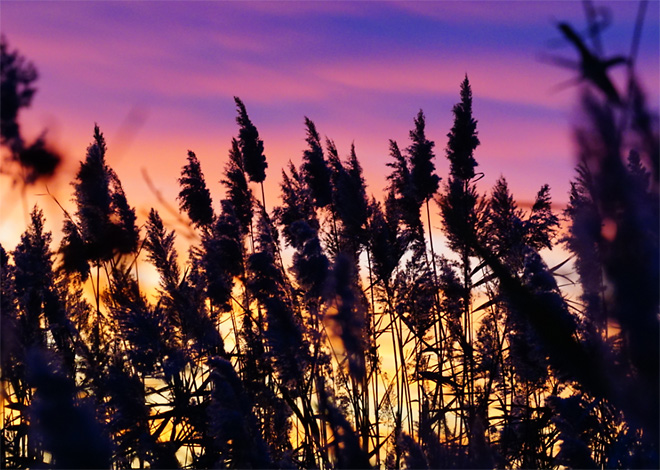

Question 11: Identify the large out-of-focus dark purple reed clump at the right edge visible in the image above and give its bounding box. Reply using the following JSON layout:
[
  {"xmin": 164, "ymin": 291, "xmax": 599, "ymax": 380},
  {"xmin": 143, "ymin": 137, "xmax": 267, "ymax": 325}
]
[{"xmin": 573, "ymin": 89, "xmax": 660, "ymax": 448}]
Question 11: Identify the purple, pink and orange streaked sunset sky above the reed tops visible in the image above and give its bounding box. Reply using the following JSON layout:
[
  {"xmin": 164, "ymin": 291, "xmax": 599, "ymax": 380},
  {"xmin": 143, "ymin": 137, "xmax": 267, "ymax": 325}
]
[{"xmin": 0, "ymin": 0, "xmax": 660, "ymax": 250}]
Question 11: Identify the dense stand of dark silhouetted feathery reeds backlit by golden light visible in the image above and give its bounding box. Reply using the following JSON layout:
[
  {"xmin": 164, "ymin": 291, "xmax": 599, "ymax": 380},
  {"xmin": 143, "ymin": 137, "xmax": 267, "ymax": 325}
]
[{"xmin": 0, "ymin": 11, "xmax": 660, "ymax": 468}]
